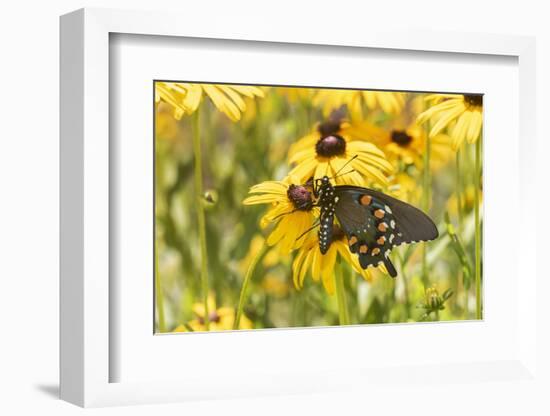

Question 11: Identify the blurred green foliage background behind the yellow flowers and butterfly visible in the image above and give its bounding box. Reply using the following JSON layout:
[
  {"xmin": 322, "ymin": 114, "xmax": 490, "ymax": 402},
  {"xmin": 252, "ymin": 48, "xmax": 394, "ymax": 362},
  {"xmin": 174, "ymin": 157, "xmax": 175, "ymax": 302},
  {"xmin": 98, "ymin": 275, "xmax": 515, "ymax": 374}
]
[{"xmin": 155, "ymin": 84, "xmax": 484, "ymax": 331}]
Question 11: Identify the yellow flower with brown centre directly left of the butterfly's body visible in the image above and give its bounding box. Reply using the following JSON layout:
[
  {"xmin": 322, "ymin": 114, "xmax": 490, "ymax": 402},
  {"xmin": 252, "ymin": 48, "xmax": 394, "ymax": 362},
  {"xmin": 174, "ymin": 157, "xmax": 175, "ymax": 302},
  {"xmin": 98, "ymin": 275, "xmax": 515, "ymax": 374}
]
[{"xmin": 243, "ymin": 178, "xmax": 314, "ymax": 253}]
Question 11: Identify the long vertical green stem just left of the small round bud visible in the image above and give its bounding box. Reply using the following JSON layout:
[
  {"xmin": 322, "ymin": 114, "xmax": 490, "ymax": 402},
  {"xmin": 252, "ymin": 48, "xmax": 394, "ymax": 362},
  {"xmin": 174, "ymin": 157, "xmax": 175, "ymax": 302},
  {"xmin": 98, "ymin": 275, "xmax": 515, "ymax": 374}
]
[{"xmin": 192, "ymin": 109, "xmax": 210, "ymax": 331}]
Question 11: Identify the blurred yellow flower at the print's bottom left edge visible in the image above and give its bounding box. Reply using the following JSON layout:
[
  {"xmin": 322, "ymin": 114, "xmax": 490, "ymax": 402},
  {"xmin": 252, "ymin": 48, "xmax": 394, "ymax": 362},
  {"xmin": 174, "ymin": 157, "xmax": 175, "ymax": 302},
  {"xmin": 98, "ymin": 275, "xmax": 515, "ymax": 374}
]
[{"xmin": 174, "ymin": 294, "xmax": 252, "ymax": 332}]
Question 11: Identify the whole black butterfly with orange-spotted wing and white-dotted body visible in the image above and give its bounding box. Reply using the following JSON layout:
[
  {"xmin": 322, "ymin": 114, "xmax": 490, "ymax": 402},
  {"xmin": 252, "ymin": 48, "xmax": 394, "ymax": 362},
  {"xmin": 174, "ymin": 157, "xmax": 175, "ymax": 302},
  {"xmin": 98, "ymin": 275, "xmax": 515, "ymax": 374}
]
[{"xmin": 310, "ymin": 176, "xmax": 439, "ymax": 277}]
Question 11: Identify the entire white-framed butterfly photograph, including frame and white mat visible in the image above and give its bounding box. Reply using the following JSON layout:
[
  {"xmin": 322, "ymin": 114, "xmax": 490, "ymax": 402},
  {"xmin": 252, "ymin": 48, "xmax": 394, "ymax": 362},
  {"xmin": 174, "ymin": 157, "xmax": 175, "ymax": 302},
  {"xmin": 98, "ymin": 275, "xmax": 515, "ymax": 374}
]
[{"xmin": 61, "ymin": 9, "xmax": 538, "ymax": 406}]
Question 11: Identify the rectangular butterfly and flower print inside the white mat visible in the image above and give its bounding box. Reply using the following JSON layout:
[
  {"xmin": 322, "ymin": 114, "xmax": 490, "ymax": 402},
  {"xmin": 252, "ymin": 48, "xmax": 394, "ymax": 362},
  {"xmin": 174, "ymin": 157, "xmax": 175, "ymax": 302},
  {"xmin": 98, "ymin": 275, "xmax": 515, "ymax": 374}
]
[{"xmin": 152, "ymin": 80, "xmax": 483, "ymax": 333}]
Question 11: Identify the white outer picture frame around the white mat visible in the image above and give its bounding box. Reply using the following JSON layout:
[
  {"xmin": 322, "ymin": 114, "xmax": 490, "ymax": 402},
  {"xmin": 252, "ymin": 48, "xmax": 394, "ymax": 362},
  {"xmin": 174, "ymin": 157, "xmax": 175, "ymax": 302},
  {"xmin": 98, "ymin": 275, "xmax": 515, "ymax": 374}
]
[{"xmin": 60, "ymin": 9, "xmax": 540, "ymax": 407}]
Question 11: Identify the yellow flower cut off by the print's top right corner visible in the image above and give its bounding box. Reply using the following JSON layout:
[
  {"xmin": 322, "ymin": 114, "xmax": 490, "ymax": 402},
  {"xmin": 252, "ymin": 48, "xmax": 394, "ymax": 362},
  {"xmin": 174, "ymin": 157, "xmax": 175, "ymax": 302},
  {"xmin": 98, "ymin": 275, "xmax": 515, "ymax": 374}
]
[{"xmin": 417, "ymin": 94, "xmax": 483, "ymax": 150}]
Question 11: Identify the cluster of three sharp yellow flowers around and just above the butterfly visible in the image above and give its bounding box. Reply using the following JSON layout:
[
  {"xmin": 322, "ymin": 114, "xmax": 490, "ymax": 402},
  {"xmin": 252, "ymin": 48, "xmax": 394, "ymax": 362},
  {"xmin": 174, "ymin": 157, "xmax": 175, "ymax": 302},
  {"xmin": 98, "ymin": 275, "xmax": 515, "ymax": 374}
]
[{"xmin": 244, "ymin": 114, "xmax": 406, "ymax": 294}]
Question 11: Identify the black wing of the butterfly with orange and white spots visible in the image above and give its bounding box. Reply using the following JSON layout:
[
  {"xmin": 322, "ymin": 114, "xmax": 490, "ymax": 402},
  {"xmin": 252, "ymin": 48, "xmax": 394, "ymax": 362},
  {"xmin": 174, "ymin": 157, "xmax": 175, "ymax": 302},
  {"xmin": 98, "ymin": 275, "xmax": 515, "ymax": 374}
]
[{"xmin": 335, "ymin": 185, "xmax": 438, "ymax": 277}]
